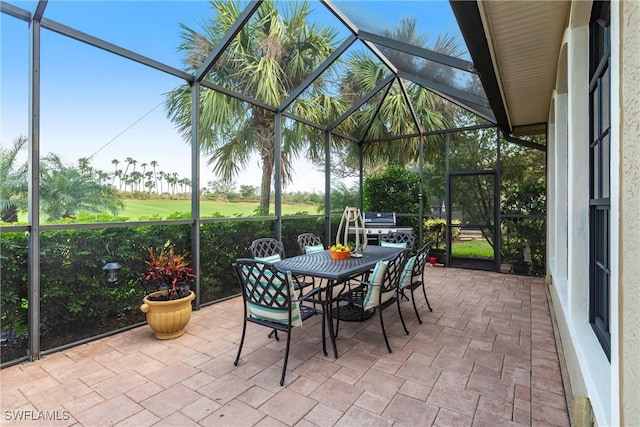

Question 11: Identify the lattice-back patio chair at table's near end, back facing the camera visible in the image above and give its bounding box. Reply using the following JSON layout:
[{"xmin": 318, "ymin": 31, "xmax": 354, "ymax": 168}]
[{"xmin": 233, "ymin": 258, "xmax": 317, "ymax": 385}]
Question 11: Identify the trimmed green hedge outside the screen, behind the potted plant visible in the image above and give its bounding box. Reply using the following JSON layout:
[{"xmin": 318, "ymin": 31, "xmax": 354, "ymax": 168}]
[{"xmin": 0, "ymin": 218, "xmax": 324, "ymax": 363}]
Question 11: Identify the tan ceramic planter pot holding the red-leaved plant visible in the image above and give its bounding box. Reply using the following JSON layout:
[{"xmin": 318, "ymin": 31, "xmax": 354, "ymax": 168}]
[{"xmin": 140, "ymin": 291, "xmax": 196, "ymax": 340}]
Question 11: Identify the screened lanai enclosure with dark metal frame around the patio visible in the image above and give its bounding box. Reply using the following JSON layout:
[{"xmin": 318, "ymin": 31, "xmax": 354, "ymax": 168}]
[{"xmin": 0, "ymin": 0, "xmax": 546, "ymax": 366}]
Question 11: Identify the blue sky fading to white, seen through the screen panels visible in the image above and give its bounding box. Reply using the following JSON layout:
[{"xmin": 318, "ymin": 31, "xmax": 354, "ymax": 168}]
[{"xmin": 0, "ymin": 0, "xmax": 457, "ymax": 192}]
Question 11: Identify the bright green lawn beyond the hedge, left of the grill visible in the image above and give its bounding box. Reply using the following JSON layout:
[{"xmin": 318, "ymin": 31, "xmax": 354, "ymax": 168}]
[{"xmin": 119, "ymin": 199, "xmax": 318, "ymax": 220}]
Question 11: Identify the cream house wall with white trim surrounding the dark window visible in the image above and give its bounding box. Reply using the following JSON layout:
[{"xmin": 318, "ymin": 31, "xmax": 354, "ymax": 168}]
[{"xmin": 547, "ymin": 1, "xmax": 640, "ymax": 425}]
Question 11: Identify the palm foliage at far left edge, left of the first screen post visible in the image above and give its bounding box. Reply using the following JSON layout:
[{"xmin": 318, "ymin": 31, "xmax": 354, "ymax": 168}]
[{"xmin": 0, "ymin": 135, "xmax": 29, "ymax": 222}]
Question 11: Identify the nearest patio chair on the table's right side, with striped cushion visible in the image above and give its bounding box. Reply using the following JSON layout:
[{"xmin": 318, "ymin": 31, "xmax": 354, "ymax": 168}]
[{"xmin": 336, "ymin": 249, "xmax": 411, "ymax": 353}]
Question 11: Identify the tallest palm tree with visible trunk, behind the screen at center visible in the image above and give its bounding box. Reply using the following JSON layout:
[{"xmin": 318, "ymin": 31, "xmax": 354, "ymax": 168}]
[{"xmin": 166, "ymin": 0, "xmax": 342, "ymax": 215}]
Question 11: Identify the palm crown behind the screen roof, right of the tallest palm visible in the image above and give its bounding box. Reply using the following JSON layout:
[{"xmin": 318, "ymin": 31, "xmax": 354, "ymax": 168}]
[{"xmin": 341, "ymin": 18, "xmax": 462, "ymax": 171}]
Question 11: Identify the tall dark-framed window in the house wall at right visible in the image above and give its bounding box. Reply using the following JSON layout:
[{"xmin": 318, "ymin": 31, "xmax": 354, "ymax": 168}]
[{"xmin": 589, "ymin": 1, "xmax": 611, "ymax": 360}]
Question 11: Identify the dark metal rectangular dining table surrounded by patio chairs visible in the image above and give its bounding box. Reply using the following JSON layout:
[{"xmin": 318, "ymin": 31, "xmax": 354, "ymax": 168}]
[{"xmin": 274, "ymin": 246, "xmax": 405, "ymax": 358}]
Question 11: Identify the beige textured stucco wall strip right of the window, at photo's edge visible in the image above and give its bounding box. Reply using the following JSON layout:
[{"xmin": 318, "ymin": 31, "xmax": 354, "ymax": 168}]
[{"xmin": 617, "ymin": 1, "xmax": 640, "ymax": 426}]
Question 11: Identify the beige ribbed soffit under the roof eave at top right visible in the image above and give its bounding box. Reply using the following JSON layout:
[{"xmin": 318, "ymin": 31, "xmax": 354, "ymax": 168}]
[{"xmin": 478, "ymin": 0, "xmax": 571, "ymax": 127}]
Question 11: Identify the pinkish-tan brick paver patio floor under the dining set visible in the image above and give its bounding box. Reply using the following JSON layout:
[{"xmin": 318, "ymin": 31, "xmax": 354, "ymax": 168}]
[{"xmin": 0, "ymin": 268, "xmax": 569, "ymax": 426}]
